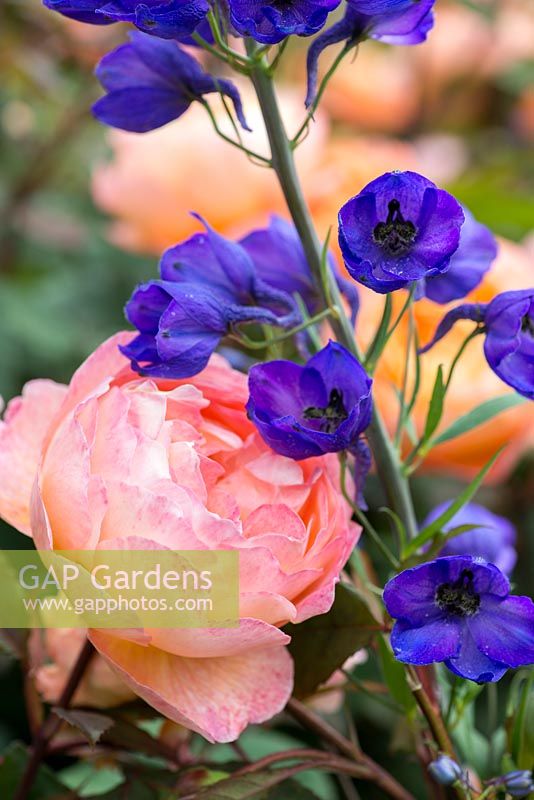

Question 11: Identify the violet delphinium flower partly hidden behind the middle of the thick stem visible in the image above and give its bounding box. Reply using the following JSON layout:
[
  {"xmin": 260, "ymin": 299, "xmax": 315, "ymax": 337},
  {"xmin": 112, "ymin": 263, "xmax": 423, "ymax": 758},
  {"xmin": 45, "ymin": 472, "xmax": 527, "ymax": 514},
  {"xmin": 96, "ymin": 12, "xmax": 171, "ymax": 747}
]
[{"xmin": 240, "ymin": 215, "xmax": 359, "ymax": 320}]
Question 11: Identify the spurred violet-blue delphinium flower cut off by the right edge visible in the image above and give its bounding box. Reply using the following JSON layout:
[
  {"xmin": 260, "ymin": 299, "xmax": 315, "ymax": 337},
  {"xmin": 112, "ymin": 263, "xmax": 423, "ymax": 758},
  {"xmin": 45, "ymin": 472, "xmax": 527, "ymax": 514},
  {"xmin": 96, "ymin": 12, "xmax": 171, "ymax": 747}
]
[{"xmin": 421, "ymin": 289, "xmax": 534, "ymax": 400}]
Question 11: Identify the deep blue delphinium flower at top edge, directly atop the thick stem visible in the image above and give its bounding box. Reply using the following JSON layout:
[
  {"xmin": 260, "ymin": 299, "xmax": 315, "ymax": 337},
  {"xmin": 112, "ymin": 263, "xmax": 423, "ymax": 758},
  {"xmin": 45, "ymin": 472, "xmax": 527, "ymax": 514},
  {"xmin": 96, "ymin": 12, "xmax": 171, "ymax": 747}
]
[{"xmin": 228, "ymin": 0, "xmax": 341, "ymax": 44}]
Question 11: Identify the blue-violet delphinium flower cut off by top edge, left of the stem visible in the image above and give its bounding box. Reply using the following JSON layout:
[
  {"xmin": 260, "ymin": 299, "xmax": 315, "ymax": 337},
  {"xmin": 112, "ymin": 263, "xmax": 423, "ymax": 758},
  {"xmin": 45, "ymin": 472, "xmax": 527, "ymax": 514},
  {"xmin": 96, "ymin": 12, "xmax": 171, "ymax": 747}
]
[{"xmin": 43, "ymin": 0, "xmax": 209, "ymax": 39}]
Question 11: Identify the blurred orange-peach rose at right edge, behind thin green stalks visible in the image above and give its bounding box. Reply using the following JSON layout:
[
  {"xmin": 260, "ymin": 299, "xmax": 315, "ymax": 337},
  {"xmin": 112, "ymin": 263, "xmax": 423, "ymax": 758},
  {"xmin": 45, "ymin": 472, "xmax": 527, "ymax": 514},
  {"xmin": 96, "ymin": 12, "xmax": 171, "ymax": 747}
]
[{"xmin": 364, "ymin": 234, "xmax": 534, "ymax": 480}]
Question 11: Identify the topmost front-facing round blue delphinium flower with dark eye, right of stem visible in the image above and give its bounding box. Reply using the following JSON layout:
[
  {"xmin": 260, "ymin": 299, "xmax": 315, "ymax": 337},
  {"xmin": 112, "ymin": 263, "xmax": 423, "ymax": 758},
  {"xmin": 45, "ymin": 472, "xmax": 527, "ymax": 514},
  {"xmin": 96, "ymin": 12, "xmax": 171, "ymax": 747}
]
[{"xmin": 339, "ymin": 172, "xmax": 464, "ymax": 294}]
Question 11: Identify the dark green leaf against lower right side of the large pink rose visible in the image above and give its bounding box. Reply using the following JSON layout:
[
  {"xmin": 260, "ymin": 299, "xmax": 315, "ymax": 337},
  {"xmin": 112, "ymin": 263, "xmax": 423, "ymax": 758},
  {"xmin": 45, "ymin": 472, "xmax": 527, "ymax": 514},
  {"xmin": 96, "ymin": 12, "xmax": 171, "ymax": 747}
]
[{"xmin": 284, "ymin": 583, "xmax": 381, "ymax": 698}]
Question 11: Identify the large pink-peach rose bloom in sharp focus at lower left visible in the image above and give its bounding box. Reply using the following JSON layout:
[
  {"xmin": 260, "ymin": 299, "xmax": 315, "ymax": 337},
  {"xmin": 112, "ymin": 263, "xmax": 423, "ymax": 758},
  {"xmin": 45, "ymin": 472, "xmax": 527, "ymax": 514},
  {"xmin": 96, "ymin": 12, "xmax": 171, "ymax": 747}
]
[{"xmin": 0, "ymin": 333, "xmax": 360, "ymax": 741}]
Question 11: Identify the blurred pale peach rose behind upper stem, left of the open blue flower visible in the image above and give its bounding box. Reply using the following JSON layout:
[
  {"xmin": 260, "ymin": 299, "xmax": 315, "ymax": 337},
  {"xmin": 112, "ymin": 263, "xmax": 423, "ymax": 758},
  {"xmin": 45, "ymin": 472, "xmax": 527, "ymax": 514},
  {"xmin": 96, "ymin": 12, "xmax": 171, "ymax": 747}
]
[{"xmin": 93, "ymin": 90, "xmax": 328, "ymax": 253}]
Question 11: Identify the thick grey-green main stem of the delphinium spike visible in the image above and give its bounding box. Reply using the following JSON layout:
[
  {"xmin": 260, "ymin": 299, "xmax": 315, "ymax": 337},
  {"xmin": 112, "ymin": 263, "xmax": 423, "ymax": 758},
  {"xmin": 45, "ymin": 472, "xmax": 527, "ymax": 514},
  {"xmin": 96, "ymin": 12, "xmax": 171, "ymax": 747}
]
[{"xmin": 247, "ymin": 47, "xmax": 417, "ymax": 539}]
